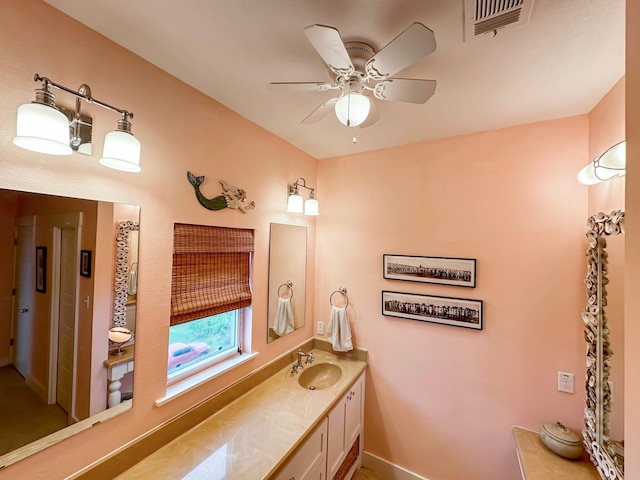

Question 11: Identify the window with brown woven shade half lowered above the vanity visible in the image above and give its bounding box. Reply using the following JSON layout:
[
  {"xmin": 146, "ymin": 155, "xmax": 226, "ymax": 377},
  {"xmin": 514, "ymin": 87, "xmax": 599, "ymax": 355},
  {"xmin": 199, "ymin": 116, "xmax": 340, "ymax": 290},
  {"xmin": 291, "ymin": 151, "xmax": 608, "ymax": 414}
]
[{"xmin": 167, "ymin": 223, "xmax": 254, "ymax": 380}]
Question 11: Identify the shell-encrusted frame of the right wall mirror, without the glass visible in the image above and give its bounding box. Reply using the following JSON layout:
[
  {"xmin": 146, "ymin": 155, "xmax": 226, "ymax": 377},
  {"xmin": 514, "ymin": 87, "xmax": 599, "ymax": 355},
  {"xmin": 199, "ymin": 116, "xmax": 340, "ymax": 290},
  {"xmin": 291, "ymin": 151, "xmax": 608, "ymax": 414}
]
[{"xmin": 582, "ymin": 210, "xmax": 624, "ymax": 480}]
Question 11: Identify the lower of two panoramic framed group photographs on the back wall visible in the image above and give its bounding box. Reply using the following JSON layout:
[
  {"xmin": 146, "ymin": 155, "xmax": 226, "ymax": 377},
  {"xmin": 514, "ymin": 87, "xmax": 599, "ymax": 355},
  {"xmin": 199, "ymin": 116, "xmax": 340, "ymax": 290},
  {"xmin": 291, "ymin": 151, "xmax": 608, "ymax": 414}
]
[{"xmin": 382, "ymin": 291, "xmax": 483, "ymax": 330}]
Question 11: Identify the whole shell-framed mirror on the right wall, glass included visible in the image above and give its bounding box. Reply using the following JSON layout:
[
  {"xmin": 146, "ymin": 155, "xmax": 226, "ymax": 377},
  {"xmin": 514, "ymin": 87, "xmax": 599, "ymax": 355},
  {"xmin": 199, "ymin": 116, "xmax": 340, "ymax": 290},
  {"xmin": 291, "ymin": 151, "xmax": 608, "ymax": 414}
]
[{"xmin": 582, "ymin": 210, "xmax": 624, "ymax": 480}]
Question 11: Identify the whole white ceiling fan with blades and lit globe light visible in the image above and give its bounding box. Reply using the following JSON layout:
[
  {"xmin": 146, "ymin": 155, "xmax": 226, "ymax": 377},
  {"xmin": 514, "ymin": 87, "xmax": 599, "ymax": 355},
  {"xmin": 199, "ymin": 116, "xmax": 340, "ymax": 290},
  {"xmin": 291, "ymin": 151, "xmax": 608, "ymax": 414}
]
[{"xmin": 269, "ymin": 22, "xmax": 436, "ymax": 127}]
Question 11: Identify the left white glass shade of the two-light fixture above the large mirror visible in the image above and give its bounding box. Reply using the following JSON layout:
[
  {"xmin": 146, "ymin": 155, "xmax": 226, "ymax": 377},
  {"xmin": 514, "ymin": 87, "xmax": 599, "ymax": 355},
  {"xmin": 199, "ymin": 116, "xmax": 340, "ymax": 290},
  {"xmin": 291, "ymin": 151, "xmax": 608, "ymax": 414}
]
[{"xmin": 13, "ymin": 103, "xmax": 73, "ymax": 155}]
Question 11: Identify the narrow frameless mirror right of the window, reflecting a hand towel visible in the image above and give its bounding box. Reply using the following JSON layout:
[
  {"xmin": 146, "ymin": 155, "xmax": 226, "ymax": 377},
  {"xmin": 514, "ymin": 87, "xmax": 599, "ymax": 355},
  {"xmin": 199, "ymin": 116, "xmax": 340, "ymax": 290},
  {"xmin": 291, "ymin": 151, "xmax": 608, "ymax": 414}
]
[{"xmin": 267, "ymin": 223, "xmax": 307, "ymax": 342}]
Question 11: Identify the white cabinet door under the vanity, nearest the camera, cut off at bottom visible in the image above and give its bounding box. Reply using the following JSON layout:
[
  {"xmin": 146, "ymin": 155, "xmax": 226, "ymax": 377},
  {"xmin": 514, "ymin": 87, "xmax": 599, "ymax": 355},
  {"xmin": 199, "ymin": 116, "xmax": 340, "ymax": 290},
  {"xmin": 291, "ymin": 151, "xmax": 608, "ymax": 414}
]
[{"xmin": 273, "ymin": 418, "xmax": 327, "ymax": 480}]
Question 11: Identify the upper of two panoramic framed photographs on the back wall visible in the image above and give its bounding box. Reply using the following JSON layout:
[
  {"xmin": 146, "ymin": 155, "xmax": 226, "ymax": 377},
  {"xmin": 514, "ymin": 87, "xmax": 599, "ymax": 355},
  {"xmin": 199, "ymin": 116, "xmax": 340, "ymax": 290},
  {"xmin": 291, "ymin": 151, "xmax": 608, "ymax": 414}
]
[{"xmin": 382, "ymin": 254, "xmax": 476, "ymax": 288}]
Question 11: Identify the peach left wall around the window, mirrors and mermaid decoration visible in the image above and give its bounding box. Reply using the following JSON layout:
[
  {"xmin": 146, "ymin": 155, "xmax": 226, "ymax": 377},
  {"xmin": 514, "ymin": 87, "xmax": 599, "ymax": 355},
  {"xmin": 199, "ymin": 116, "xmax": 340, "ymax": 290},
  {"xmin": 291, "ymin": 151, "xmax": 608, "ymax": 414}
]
[{"xmin": 0, "ymin": 0, "xmax": 324, "ymax": 480}]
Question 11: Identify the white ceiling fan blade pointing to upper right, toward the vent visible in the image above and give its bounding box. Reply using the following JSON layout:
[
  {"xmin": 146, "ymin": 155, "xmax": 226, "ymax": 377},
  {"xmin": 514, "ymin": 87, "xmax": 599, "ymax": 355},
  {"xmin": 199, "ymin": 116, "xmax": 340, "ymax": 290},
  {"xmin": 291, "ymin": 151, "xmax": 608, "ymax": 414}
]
[{"xmin": 365, "ymin": 22, "xmax": 436, "ymax": 80}]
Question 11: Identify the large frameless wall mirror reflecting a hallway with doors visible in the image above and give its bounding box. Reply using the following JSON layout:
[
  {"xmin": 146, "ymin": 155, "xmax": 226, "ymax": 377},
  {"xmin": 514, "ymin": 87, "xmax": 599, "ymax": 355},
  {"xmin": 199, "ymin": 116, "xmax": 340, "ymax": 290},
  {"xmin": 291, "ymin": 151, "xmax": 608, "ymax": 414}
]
[{"xmin": 0, "ymin": 189, "xmax": 140, "ymax": 468}]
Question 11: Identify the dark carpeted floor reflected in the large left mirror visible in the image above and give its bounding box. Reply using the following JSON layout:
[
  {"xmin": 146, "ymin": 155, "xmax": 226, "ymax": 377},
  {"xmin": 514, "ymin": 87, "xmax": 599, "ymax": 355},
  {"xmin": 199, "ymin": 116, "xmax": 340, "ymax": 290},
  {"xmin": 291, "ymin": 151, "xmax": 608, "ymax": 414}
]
[{"xmin": 0, "ymin": 365, "xmax": 68, "ymax": 455}]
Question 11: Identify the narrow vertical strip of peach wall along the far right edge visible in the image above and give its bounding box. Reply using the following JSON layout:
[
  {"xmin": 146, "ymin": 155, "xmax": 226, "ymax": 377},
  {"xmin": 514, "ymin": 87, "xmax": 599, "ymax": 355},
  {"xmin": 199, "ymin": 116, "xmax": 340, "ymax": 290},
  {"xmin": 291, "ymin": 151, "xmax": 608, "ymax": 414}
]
[{"xmin": 624, "ymin": 1, "xmax": 640, "ymax": 479}]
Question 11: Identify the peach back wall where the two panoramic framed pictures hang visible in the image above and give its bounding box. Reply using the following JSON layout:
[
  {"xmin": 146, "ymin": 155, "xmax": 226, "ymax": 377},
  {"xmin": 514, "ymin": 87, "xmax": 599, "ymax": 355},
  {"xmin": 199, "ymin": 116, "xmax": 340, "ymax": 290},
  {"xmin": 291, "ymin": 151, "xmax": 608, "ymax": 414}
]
[{"xmin": 316, "ymin": 116, "xmax": 589, "ymax": 480}]
